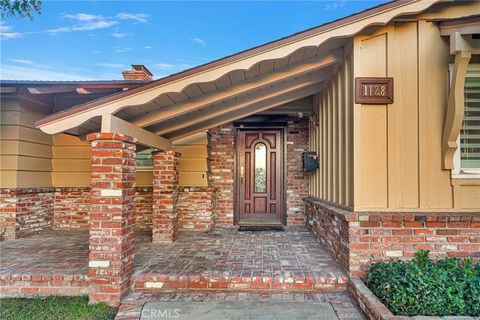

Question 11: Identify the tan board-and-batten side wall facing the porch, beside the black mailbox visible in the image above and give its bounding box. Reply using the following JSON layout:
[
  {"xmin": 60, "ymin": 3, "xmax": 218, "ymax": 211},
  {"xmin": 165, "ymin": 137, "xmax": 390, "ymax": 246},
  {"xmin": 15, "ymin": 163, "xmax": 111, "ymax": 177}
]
[{"xmin": 309, "ymin": 44, "xmax": 353, "ymax": 208}]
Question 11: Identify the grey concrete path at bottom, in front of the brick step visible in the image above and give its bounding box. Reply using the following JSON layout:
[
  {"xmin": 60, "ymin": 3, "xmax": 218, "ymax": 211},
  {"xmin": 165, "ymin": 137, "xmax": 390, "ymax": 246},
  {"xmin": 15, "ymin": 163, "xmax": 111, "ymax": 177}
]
[{"xmin": 140, "ymin": 301, "xmax": 338, "ymax": 320}]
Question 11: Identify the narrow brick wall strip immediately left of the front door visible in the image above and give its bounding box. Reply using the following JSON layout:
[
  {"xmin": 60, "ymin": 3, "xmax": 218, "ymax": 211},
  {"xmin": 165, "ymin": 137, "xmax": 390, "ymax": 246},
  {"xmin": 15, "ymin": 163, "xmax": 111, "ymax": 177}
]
[{"xmin": 208, "ymin": 124, "xmax": 235, "ymax": 226}]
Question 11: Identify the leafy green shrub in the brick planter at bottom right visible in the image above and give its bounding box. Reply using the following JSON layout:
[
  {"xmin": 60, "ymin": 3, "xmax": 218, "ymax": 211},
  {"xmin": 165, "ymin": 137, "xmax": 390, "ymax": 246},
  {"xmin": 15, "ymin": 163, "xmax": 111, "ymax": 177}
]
[{"xmin": 365, "ymin": 251, "xmax": 480, "ymax": 316}]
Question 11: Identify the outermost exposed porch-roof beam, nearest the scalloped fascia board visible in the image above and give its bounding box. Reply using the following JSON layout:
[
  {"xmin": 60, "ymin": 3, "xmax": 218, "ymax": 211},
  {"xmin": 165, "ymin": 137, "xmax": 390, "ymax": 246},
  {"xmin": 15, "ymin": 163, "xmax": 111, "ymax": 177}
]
[{"xmin": 132, "ymin": 49, "xmax": 343, "ymax": 127}]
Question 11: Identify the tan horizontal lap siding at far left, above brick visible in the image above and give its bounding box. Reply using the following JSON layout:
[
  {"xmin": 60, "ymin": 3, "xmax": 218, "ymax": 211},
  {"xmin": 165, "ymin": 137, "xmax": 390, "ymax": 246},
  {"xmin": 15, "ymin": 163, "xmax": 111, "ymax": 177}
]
[{"xmin": 0, "ymin": 95, "xmax": 52, "ymax": 188}]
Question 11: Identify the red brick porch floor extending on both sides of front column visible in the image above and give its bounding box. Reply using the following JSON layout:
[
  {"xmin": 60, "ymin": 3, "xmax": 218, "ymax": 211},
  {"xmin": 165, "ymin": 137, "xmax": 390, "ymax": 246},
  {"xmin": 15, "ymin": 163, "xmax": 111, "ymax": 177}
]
[{"xmin": 0, "ymin": 227, "xmax": 348, "ymax": 292}]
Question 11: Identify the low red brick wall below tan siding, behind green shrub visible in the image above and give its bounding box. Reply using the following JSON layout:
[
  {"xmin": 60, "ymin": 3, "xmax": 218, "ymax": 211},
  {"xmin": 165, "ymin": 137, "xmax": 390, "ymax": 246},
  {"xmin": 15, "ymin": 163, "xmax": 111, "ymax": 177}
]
[{"xmin": 305, "ymin": 198, "xmax": 480, "ymax": 276}]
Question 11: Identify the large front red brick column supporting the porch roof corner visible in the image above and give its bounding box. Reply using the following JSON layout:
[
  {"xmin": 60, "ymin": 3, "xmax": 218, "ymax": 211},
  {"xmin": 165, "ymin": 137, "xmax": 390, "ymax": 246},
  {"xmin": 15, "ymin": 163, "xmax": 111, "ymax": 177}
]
[{"xmin": 87, "ymin": 133, "xmax": 137, "ymax": 306}]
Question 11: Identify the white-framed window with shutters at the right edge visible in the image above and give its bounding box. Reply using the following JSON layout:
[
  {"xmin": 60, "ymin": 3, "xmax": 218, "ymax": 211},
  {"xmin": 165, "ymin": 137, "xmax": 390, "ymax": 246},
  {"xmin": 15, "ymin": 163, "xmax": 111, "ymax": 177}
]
[{"xmin": 453, "ymin": 63, "xmax": 480, "ymax": 177}]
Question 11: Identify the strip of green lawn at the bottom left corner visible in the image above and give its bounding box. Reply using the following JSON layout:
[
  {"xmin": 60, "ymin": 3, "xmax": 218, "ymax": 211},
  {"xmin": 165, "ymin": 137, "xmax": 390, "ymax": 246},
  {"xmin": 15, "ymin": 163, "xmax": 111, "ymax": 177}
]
[{"xmin": 0, "ymin": 297, "xmax": 117, "ymax": 320}]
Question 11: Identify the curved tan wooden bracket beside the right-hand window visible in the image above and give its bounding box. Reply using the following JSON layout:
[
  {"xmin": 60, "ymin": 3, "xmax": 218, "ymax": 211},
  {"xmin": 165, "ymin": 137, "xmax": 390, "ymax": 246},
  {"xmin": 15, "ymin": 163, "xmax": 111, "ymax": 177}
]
[{"xmin": 442, "ymin": 51, "xmax": 471, "ymax": 169}]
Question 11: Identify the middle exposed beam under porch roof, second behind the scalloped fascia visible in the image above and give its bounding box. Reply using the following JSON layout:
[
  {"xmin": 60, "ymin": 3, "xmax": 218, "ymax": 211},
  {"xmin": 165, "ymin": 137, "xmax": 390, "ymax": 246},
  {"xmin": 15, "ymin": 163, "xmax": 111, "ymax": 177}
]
[{"xmin": 155, "ymin": 73, "xmax": 330, "ymax": 135}]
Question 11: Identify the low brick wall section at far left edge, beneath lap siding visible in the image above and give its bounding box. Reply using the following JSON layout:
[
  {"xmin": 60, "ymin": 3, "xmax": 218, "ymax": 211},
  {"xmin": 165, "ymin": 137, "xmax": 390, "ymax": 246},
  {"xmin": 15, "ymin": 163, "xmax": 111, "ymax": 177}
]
[{"xmin": 0, "ymin": 188, "xmax": 53, "ymax": 240}]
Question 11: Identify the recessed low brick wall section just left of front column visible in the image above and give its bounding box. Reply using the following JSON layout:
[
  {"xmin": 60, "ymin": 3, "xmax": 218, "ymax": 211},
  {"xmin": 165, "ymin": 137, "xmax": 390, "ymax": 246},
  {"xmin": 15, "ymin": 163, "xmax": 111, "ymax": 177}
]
[{"xmin": 53, "ymin": 187, "xmax": 90, "ymax": 230}]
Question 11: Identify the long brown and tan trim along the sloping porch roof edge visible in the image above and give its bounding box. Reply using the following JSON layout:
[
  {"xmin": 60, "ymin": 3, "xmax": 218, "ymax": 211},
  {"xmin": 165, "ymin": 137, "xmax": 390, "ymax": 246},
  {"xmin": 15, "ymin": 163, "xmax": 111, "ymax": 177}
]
[{"xmin": 35, "ymin": 0, "xmax": 418, "ymax": 127}]
